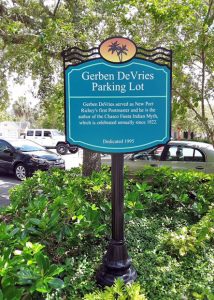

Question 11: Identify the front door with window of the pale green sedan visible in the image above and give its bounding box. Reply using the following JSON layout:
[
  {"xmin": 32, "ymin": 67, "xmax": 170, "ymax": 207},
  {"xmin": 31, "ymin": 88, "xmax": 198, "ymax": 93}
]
[{"xmin": 160, "ymin": 144, "xmax": 206, "ymax": 171}]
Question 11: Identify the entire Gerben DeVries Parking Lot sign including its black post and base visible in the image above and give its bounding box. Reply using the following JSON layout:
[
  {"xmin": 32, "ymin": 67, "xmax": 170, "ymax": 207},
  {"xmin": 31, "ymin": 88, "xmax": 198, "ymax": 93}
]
[{"xmin": 62, "ymin": 37, "xmax": 172, "ymax": 285}]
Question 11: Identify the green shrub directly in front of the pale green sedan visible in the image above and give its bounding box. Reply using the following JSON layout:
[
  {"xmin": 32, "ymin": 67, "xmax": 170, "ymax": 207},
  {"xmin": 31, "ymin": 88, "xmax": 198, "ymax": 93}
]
[{"xmin": 136, "ymin": 167, "xmax": 214, "ymax": 218}]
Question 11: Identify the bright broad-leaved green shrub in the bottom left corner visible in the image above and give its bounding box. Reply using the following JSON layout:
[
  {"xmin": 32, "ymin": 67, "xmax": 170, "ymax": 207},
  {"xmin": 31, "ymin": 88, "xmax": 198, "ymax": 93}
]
[{"xmin": 0, "ymin": 223, "xmax": 64, "ymax": 300}]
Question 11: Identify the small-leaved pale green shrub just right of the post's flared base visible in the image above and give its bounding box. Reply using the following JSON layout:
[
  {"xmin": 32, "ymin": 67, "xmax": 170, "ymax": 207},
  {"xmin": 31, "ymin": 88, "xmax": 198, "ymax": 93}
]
[{"xmin": 126, "ymin": 216, "xmax": 214, "ymax": 300}]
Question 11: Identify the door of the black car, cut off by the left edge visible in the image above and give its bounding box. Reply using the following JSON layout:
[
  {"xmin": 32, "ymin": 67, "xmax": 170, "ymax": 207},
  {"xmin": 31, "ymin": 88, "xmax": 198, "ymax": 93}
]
[{"xmin": 0, "ymin": 141, "xmax": 15, "ymax": 172}]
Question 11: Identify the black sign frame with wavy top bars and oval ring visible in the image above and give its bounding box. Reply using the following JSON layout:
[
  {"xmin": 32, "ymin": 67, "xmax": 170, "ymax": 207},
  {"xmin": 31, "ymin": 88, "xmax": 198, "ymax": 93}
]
[{"xmin": 62, "ymin": 36, "xmax": 172, "ymax": 154}]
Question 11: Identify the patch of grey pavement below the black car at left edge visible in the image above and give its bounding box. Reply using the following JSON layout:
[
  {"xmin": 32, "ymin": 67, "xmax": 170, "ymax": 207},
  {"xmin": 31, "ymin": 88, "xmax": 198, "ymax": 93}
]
[{"xmin": 0, "ymin": 173, "xmax": 20, "ymax": 206}]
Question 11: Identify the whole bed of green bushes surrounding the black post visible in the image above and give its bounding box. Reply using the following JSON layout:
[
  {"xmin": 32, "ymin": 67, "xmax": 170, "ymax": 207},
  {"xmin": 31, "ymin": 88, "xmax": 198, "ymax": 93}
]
[{"xmin": 0, "ymin": 168, "xmax": 214, "ymax": 300}]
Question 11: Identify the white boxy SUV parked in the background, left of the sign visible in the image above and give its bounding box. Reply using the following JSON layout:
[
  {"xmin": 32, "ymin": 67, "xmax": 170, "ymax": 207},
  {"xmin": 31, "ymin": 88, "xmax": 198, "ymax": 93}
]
[{"xmin": 25, "ymin": 129, "xmax": 78, "ymax": 155}]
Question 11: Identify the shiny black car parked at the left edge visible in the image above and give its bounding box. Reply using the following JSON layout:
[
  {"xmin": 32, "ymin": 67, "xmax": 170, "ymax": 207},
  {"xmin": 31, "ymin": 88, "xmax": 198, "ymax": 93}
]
[{"xmin": 0, "ymin": 139, "xmax": 65, "ymax": 180}]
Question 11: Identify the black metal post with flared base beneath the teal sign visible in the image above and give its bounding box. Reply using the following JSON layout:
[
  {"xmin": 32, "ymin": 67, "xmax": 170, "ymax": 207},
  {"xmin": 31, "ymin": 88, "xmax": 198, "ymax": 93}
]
[{"xmin": 97, "ymin": 154, "xmax": 137, "ymax": 286}]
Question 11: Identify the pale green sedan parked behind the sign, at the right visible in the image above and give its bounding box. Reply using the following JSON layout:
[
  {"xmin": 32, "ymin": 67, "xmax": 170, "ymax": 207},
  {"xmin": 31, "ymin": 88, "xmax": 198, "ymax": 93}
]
[{"xmin": 102, "ymin": 141, "xmax": 214, "ymax": 173}]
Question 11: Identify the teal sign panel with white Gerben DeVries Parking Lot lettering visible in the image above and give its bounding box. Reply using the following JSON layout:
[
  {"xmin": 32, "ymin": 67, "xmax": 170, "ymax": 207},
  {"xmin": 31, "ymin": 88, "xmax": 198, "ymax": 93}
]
[{"xmin": 65, "ymin": 58, "xmax": 171, "ymax": 153}]
